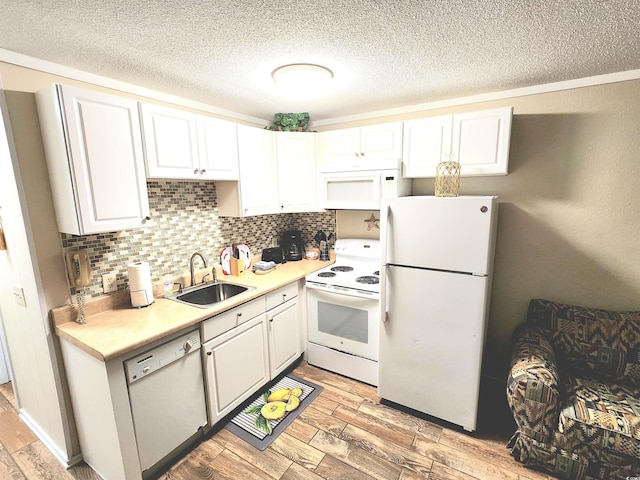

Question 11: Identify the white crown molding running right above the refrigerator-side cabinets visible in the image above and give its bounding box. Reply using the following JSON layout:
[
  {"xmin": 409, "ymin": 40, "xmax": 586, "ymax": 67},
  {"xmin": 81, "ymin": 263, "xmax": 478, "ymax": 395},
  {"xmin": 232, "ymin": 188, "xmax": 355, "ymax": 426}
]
[{"xmin": 310, "ymin": 70, "xmax": 640, "ymax": 127}]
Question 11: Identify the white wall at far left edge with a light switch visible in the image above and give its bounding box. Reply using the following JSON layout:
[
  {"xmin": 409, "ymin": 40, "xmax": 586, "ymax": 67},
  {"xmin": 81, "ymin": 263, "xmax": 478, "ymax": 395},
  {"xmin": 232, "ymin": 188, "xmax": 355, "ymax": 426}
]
[{"xmin": 0, "ymin": 78, "xmax": 78, "ymax": 464}]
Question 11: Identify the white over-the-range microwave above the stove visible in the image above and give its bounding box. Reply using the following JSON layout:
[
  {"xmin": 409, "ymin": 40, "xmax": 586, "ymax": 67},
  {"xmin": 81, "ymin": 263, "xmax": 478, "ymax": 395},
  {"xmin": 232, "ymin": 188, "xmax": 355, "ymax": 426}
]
[{"xmin": 320, "ymin": 169, "xmax": 411, "ymax": 210}]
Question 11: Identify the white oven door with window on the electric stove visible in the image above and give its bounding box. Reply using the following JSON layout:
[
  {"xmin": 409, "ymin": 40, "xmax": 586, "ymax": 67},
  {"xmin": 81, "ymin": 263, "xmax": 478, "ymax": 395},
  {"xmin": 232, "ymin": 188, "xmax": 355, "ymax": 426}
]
[{"xmin": 307, "ymin": 285, "xmax": 380, "ymax": 361}]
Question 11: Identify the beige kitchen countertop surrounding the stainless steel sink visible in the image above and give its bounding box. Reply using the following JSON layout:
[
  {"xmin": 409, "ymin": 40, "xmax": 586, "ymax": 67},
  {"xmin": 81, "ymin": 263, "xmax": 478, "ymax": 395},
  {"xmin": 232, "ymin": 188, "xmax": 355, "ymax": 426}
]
[{"xmin": 51, "ymin": 252, "xmax": 334, "ymax": 362}]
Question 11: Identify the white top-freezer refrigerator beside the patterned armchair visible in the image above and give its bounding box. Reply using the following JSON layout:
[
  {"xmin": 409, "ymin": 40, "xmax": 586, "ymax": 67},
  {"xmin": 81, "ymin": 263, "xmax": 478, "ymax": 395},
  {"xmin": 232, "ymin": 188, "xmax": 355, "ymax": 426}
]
[{"xmin": 378, "ymin": 196, "xmax": 498, "ymax": 431}]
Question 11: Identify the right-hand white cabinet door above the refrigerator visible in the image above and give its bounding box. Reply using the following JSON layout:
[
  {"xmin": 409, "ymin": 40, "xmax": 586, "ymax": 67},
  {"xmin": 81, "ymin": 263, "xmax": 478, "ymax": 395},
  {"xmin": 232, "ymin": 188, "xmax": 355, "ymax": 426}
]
[{"xmin": 452, "ymin": 107, "xmax": 513, "ymax": 176}]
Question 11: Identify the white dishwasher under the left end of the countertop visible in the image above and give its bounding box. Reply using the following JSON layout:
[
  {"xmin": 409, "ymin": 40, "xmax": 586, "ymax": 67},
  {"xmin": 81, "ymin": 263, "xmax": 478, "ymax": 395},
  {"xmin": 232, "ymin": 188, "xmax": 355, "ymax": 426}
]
[{"xmin": 124, "ymin": 330, "xmax": 207, "ymax": 477}]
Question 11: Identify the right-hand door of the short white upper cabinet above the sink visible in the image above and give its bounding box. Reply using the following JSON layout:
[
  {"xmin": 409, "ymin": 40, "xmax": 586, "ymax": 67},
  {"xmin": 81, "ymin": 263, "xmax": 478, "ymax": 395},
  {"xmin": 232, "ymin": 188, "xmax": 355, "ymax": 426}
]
[{"xmin": 196, "ymin": 115, "xmax": 238, "ymax": 180}]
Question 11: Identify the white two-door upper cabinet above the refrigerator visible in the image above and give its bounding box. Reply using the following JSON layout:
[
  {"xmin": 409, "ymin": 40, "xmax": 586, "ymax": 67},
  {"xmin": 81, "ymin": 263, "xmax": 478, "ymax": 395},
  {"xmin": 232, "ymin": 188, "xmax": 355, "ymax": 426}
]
[{"xmin": 403, "ymin": 107, "xmax": 513, "ymax": 178}]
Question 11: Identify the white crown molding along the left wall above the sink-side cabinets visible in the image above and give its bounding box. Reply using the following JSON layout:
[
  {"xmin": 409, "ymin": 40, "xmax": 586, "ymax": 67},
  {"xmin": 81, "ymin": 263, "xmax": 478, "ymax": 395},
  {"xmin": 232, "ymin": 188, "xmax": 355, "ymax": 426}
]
[{"xmin": 0, "ymin": 48, "xmax": 271, "ymax": 126}]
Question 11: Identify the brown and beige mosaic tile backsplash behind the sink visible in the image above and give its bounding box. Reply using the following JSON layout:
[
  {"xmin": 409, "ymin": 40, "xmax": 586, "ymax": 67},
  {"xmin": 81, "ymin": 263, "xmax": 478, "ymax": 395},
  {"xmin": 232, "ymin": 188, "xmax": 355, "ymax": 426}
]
[{"xmin": 60, "ymin": 181, "xmax": 336, "ymax": 297}]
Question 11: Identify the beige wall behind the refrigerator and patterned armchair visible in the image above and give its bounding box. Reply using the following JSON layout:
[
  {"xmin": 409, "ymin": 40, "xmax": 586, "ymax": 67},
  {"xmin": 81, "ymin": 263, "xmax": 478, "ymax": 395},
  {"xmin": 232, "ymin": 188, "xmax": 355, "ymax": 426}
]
[{"xmin": 331, "ymin": 80, "xmax": 640, "ymax": 378}]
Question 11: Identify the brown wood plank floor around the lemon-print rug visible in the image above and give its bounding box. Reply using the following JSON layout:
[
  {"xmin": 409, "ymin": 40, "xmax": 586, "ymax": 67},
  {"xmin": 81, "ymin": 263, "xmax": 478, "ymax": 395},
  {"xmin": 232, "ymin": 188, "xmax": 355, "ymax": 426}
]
[{"xmin": 0, "ymin": 362, "xmax": 553, "ymax": 480}]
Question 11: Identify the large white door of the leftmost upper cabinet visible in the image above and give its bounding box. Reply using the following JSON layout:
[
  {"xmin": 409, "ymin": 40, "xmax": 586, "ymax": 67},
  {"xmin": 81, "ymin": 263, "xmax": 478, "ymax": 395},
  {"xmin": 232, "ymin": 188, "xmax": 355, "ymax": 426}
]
[{"xmin": 55, "ymin": 86, "xmax": 149, "ymax": 235}]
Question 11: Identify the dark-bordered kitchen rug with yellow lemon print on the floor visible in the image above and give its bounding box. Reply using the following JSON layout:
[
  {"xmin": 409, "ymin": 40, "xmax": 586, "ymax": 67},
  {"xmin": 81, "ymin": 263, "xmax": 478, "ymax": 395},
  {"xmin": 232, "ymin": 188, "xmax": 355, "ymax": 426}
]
[{"xmin": 224, "ymin": 374, "xmax": 323, "ymax": 450}]
